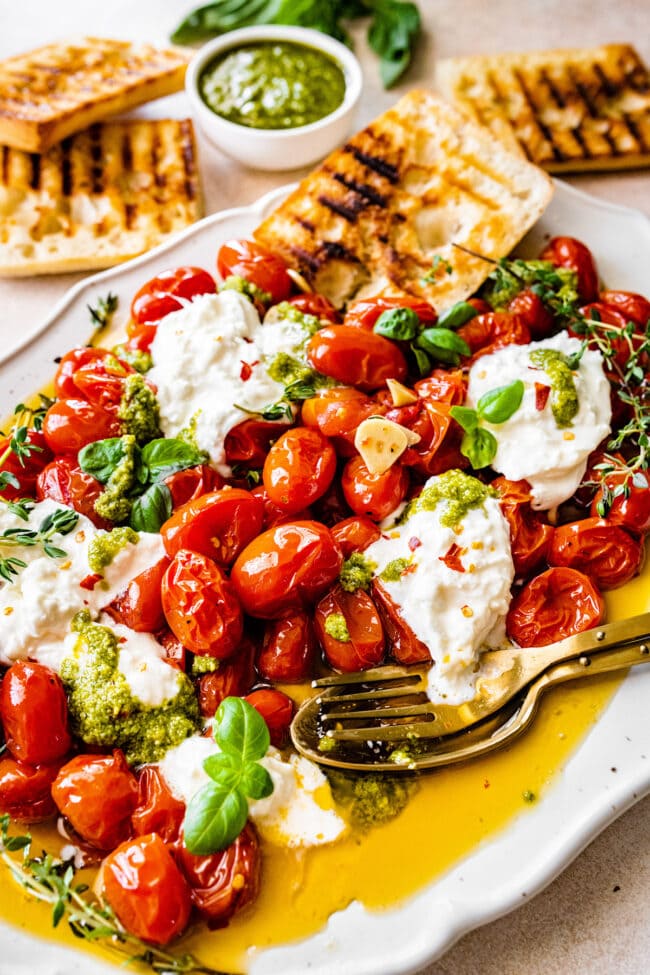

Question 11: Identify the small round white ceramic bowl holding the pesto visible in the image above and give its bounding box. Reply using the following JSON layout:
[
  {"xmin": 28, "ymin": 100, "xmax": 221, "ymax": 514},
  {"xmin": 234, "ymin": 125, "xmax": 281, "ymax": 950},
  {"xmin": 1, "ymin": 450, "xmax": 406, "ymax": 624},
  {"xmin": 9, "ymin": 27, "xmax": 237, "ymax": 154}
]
[{"xmin": 185, "ymin": 27, "xmax": 363, "ymax": 171}]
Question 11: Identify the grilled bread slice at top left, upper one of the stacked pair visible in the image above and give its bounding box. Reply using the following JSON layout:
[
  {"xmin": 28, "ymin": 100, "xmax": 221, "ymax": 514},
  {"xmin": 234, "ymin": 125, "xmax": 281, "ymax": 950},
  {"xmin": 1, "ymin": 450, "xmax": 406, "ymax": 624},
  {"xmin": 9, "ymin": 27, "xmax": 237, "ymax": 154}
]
[{"xmin": 0, "ymin": 37, "xmax": 187, "ymax": 152}]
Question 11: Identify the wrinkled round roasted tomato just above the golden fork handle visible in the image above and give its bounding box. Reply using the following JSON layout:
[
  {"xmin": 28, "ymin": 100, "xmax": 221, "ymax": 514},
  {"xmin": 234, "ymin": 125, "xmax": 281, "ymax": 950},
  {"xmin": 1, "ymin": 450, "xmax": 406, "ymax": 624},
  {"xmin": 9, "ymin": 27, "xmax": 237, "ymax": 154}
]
[{"xmin": 506, "ymin": 567, "xmax": 605, "ymax": 647}]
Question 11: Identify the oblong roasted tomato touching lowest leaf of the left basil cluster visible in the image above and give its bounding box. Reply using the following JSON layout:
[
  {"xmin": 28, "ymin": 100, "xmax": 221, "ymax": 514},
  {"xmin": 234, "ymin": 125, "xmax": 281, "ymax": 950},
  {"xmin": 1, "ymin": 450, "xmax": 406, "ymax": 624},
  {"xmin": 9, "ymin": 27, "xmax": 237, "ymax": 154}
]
[{"xmin": 160, "ymin": 487, "xmax": 264, "ymax": 568}]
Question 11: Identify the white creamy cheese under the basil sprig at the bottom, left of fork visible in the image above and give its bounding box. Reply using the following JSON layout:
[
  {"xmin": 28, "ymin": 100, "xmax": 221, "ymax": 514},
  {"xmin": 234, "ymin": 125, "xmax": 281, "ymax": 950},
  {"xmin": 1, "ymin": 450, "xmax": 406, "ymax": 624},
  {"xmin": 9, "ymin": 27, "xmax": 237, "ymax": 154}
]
[{"xmin": 159, "ymin": 735, "xmax": 347, "ymax": 847}]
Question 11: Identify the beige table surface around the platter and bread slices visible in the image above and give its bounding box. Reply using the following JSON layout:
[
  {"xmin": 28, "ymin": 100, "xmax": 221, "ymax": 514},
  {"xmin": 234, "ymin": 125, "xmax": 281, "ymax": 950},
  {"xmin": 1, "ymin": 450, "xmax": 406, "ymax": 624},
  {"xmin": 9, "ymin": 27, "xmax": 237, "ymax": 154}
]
[{"xmin": 0, "ymin": 0, "xmax": 650, "ymax": 975}]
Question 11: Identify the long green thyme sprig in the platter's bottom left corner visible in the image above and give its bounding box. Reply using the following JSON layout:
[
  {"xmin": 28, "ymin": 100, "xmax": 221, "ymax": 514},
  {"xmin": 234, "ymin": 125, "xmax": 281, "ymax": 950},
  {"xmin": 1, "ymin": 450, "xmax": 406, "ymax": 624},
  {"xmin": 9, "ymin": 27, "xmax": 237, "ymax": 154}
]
[{"xmin": 0, "ymin": 814, "xmax": 225, "ymax": 975}]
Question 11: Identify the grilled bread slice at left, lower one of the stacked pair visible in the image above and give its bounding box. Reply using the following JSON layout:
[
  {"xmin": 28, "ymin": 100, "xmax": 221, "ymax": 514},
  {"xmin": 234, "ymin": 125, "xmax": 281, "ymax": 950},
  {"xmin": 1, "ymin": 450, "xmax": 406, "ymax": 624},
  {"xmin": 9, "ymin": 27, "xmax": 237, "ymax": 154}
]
[{"xmin": 0, "ymin": 119, "xmax": 201, "ymax": 277}]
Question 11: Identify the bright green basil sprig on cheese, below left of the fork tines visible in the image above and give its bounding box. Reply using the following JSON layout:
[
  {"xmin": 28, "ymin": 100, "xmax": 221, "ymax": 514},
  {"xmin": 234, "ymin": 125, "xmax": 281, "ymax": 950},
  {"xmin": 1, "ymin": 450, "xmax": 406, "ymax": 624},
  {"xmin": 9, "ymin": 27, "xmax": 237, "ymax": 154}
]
[{"xmin": 183, "ymin": 697, "xmax": 273, "ymax": 856}]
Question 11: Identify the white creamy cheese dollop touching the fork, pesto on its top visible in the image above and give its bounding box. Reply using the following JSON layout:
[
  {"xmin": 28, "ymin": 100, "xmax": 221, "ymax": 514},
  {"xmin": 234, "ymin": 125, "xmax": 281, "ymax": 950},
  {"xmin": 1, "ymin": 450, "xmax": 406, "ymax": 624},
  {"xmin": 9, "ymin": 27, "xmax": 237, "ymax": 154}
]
[{"xmin": 364, "ymin": 477, "xmax": 514, "ymax": 703}]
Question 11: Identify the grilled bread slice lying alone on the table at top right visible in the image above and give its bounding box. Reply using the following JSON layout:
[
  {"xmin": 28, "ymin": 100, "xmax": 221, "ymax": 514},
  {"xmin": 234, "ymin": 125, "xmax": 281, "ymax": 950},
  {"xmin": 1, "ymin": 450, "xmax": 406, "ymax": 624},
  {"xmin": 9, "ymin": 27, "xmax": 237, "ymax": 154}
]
[{"xmin": 435, "ymin": 44, "xmax": 650, "ymax": 172}]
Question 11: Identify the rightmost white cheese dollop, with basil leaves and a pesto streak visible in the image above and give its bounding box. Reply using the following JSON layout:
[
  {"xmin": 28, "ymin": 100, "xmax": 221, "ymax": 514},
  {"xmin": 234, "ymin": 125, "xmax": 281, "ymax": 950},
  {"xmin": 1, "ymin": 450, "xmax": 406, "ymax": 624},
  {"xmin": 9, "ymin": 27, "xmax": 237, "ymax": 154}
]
[{"xmin": 467, "ymin": 332, "xmax": 612, "ymax": 510}]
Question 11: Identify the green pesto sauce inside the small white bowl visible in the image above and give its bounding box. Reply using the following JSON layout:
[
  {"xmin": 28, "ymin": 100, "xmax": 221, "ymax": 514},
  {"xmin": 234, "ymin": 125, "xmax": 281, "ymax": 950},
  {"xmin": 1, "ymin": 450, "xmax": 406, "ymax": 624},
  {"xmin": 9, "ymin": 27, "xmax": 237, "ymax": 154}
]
[{"xmin": 199, "ymin": 41, "xmax": 345, "ymax": 129}]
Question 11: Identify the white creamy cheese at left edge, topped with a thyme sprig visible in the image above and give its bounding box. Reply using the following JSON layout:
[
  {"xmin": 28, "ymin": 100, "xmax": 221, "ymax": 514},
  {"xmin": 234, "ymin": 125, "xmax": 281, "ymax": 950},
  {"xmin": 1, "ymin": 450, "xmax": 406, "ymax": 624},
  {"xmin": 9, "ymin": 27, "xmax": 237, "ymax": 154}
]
[{"xmin": 0, "ymin": 500, "xmax": 165, "ymax": 670}]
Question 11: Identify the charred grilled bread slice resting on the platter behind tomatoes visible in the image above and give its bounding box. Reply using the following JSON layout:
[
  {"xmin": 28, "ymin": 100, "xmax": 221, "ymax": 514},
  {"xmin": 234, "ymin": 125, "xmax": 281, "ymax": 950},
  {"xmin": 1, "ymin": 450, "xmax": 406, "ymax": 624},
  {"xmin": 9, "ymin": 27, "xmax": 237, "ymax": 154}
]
[{"xmin": 255, "ymin": 91, "xmax": 552, "ymax": 309}]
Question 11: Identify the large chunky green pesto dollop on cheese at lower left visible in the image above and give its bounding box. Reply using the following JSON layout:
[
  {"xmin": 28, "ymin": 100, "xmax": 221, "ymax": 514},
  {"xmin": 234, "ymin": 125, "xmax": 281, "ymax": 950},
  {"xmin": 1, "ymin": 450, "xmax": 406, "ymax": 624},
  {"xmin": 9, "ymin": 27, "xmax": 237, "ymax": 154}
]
[{"xmin": 61, "ymin": 611, "xmax": 200, "ymax": 765}]
